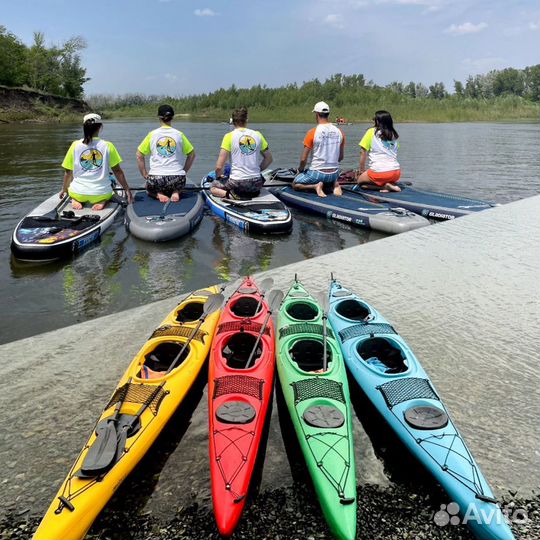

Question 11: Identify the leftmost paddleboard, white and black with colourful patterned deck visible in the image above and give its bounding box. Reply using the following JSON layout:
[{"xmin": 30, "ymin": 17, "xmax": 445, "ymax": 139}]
[{"xmin": 11, "ymin": 193, "xmax": 124, "ymax": 262}]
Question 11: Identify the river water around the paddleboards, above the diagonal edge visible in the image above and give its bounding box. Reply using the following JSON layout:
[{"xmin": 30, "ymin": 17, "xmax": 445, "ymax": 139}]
[{"xmin": 0, "ymin": 119, "xmax": 540, "ymax": 343}]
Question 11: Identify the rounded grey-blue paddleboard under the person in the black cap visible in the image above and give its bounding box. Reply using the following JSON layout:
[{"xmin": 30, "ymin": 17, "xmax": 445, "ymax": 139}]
[{"xmin": 126, "ymin": 186, "xmax": 204, "ymax": 242}]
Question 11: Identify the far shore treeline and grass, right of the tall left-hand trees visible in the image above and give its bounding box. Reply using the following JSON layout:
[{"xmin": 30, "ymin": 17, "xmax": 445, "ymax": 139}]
[{"xmin": 88, "ymin": 65, "xmax": 540, "ymax": 122}]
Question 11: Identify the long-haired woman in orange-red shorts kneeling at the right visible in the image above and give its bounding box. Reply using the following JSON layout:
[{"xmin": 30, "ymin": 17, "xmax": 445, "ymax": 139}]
[{"xmin": 356, "ymin": 111, "xmax": 401, "ymax": 192}]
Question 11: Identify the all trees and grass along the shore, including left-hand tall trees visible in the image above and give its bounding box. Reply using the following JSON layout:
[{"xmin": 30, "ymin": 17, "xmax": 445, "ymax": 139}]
[{"xmin": 0, "ymin": 26, "xmax": 540, "ymax": 122}]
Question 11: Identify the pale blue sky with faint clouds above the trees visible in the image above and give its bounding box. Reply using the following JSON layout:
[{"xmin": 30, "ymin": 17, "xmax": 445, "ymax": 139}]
[{"xmin": 0, "ymin": 0, "xmax": 540, "ymax": 96}]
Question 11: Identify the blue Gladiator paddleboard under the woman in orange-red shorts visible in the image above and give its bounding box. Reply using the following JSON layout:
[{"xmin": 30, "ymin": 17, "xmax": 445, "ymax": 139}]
[{"xmin": 341, "ymin": 173, "xmax": 500, "ymax": 221}]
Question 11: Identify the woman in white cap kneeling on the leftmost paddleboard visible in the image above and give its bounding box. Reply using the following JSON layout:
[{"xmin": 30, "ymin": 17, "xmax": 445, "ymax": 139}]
[{"xmin": 60, "ymin": 113, "xmax": 133, "ymax": 210}]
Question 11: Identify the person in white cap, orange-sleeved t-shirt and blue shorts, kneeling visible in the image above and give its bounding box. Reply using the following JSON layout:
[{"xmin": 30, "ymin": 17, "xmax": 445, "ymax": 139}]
[{"xmin": 292, "ymin": 101, "xmax": 345, "ymax": 197}]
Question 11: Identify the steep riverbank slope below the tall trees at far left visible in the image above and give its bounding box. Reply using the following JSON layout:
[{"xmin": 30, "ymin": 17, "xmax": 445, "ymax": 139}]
[{"xmin": 0, "ymin": 85, "xmax": 90, "ymax": 123}]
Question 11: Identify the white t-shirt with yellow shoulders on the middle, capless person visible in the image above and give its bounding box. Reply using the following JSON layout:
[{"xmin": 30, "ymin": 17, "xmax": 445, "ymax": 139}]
[{"xmin": 221, "ymin": 128, "xmax": 268, "ymax": 180}]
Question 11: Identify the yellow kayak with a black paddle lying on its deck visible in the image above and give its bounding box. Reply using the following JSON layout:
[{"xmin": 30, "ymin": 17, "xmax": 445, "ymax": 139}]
[{"xmin": 33, "ymin": 287, "xmax": 223, "ymax": 540}]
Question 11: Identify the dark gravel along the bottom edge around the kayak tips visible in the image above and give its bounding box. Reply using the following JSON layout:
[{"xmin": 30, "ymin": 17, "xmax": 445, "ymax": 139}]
[{"xmin": 0, "ymin": 484, "xmax": 540, "ymax": 540}]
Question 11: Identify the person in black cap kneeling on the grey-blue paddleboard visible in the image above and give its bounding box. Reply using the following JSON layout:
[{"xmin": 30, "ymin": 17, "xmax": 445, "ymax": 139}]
[{"xmin": 137, "ymin": 105, "xmax": 195, "ymax": 203}]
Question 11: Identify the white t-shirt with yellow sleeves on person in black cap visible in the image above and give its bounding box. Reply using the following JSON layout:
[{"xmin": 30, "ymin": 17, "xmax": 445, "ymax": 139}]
[{"xmin": 138, "ymin": 126, "xmax": 193, "ymax": 176}]
